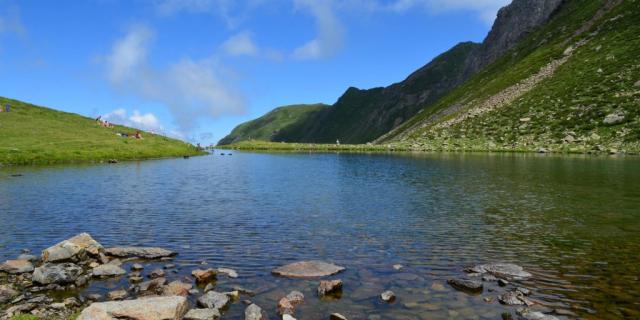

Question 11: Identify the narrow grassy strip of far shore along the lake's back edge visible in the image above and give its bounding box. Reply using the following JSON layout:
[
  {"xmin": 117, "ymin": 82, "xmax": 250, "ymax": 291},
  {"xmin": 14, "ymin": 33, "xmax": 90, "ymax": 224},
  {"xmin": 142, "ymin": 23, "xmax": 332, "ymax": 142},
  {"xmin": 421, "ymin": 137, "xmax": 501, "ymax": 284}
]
[{"xmin": 216, "ymin": 140, "xmax": 640, "ymax": 156}]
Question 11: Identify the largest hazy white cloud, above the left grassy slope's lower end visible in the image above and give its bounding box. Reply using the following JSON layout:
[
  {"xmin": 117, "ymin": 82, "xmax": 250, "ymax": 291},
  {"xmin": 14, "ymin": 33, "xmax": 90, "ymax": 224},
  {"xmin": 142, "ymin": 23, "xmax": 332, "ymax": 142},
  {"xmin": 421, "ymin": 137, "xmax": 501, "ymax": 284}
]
[{"xmin": 105, "ymin": 26, "xmax": 245, "ymax": 133}]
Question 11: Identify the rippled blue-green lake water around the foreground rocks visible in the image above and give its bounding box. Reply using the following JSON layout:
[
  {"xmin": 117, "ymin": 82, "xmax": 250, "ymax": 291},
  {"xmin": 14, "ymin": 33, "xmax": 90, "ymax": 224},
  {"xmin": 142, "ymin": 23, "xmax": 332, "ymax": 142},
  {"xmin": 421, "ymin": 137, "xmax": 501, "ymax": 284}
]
[{"xmin": 0, "ymin": 152, "xmax": 640, "ymax": 319}]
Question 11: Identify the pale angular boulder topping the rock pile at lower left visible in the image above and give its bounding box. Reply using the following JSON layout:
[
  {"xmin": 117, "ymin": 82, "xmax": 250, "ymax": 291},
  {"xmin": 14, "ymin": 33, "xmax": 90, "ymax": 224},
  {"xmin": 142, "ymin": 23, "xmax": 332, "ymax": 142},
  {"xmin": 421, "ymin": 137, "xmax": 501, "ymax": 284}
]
[{"xmin": 42, "ymin": 233, "xmax": 103, "ymax": 262}]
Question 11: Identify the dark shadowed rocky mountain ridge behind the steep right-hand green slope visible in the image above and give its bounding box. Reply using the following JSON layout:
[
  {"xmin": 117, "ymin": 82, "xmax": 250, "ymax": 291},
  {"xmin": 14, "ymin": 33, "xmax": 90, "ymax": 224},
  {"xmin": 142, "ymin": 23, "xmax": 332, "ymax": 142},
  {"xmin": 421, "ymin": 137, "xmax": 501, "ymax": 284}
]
[{"xmin": 220, "ymin": 0, "xmax": 562, "ymax": 144}]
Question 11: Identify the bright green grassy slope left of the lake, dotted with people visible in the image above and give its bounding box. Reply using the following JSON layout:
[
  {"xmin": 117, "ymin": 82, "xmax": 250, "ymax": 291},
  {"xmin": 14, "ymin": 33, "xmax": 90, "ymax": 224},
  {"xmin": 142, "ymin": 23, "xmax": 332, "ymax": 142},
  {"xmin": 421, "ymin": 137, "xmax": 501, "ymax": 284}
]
[{"xmin": 0, "ymin": 97, "xmax": 199, "ymax": 165}]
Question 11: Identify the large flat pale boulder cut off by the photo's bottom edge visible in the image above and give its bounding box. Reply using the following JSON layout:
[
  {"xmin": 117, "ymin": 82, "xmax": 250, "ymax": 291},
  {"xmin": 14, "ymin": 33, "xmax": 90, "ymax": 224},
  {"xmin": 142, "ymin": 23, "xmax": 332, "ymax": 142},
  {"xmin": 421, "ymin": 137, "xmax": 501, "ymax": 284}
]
[{"xmin": 77, "ymin": 296, "xmax": 188, "ymax": 320}]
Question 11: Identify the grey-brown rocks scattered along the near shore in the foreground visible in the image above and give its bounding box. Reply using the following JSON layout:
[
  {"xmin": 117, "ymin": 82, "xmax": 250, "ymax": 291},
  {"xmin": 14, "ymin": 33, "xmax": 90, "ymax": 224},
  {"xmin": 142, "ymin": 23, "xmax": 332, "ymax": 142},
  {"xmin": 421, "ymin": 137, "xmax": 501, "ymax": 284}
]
[{"xmin": 0, "ymin": 233, "xmax": 558, "ymax": 320}]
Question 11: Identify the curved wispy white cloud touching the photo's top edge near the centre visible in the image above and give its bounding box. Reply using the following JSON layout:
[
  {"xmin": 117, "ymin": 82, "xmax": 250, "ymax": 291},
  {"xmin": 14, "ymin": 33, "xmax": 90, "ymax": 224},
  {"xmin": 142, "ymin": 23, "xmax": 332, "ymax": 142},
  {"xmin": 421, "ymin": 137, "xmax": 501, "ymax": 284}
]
[{"xmin": 293, "ymin": 0, "xmax": 344, "ymax": 59}]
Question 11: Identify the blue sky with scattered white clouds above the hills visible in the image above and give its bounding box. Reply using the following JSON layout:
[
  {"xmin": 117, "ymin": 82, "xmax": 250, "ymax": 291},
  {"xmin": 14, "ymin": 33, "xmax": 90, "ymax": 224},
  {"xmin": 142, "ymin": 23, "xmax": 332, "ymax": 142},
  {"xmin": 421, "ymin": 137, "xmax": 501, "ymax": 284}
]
[{"xmin": 0, "ymin": 0, "xmax": 510, "ymax": 144}]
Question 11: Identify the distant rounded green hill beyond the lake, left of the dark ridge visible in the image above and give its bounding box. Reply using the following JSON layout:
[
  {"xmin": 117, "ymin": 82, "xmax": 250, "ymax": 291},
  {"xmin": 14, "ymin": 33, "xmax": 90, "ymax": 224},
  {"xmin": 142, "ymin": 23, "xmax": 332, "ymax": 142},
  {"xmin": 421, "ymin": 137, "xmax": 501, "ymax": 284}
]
[{"xmin": 218, "ymin": 104, "xmax": 327, "ymax": 145}]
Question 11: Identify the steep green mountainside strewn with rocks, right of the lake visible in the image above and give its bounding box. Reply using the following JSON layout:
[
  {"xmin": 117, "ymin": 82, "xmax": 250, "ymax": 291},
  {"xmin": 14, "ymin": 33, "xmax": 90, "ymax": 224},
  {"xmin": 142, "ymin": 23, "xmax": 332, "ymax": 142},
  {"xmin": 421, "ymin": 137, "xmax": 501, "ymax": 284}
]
[{"xmin": 381, "ymin": 0, "xmax": 640, "ymax": 152}]
